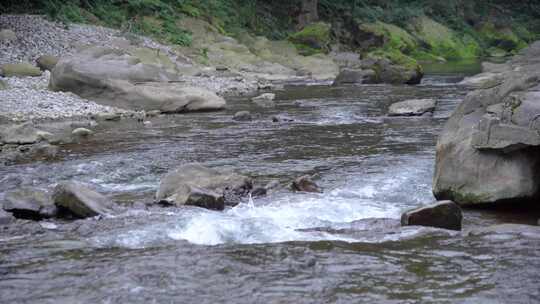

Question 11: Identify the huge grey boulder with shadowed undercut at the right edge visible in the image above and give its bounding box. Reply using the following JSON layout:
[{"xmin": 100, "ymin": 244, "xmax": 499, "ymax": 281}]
[{"xmin": 433, "ymin": 43, "xmax": 540, "ymax": 205}]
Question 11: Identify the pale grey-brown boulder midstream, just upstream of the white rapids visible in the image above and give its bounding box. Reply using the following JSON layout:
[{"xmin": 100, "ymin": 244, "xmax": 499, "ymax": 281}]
[{"xmin": 156, "ymin": 163, "xmax": 253, "ymax": 210}]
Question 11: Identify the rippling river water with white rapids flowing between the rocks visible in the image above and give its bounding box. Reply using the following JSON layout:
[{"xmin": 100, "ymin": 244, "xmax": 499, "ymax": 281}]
[{"xmin": 0, "ymin": 65, "xmax": 540, "ymax": 304}]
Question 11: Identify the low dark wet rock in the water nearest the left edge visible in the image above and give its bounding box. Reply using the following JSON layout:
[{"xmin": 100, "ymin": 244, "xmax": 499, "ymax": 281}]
[{"xmin": 3, "ymin": 188, "xmax": 56, "ymax": 220}]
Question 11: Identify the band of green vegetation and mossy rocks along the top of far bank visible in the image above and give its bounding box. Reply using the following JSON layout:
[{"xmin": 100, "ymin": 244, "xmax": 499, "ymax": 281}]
[{"xmin": 0, "ymin": 0, "xmax": 540, "ymax": 64}]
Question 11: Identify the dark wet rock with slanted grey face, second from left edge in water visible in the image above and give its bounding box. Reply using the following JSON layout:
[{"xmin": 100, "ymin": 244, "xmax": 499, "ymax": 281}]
[{"xmin": 53, "ymin": 181, "xmax": 113, "ymax": 218}]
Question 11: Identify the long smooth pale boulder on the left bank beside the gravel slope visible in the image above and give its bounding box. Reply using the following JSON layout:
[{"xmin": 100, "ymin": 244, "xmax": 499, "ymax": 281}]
[{"xmin": 49, "ymin": 47, "xmax": 225, "ymax": 113}]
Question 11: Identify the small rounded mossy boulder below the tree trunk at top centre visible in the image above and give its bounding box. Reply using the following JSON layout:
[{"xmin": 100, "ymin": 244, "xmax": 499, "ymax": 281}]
[{"xmin": 289, "ymin": 22, "xmax": 331, "ymax": 56}]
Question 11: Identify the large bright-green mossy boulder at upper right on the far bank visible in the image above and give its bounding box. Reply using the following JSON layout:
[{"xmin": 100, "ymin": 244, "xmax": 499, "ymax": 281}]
[{"xmin": 410, "ymin": 17, "xmax": 482, "ymax": 59}]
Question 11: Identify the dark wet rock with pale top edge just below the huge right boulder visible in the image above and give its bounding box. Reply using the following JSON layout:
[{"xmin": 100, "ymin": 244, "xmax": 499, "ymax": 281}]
[{"xmin": 401, "ymin": 201, "xmax": 463, "ymax": 230}]
